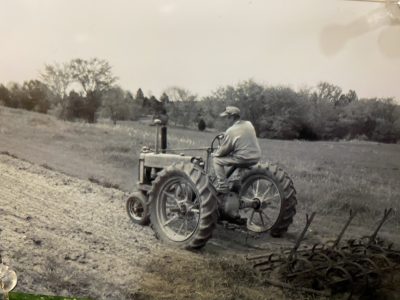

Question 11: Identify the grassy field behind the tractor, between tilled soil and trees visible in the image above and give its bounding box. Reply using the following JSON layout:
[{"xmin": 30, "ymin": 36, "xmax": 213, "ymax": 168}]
[{"xmin": 0, "ymin": 107, "xmax": 400, "ymax": 226}]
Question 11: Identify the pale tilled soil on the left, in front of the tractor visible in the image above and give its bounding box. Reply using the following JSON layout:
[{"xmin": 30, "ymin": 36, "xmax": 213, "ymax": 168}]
[{"xmin": 0, "ymin": 155, "xmax": 160, "ymax": 299}]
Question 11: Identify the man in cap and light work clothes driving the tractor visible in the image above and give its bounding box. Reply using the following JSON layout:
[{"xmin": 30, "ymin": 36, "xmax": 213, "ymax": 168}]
[{"xmin": 213, "ymin": 106, "xmax": 261, "ymax": 193}]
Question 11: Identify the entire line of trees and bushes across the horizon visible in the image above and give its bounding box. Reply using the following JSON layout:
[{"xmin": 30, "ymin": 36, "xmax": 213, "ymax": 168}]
[{"xmin": 0, "ymin": 58, "xmax": 400, "ymax": 143}]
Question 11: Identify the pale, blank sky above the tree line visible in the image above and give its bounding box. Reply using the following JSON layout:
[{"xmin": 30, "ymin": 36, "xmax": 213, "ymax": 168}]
[{"xmin": 0, "ymin": 0, "xmax": 400, "ymax": 103}]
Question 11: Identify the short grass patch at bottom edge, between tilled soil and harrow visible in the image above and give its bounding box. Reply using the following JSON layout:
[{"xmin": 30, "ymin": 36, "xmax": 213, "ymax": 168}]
[{"xmin": 136, "ymin": 252, "xmax": 290, "ymax": 300}]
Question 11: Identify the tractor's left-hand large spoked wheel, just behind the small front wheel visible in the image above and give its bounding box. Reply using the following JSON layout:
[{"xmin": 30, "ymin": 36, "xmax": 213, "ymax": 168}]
[{"xmin": 150, "ymin": 163, "xmax": 217, "ymax": 249}]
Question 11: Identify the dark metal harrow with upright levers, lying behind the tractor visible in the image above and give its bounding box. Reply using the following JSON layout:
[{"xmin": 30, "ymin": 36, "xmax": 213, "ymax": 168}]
[{"xmin": 247, "ymin": 209, "xmax": 400, "ymax": 297}]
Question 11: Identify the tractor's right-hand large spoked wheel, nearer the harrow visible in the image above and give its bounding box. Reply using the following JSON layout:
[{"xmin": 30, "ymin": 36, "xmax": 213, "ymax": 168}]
[{"xmin": 239, "ymin": 163, "xmax": 297, "ymax": 237}]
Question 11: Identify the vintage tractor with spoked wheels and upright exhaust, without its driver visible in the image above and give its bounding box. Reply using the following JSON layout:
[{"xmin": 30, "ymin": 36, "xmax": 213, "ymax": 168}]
[{"xmin": 126, "ymin": 120, "xmax": 297, "ymax": 248}]
